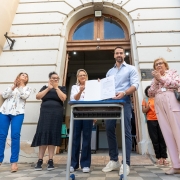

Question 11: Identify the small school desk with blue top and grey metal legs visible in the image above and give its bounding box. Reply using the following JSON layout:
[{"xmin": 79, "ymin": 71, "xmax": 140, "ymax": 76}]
[{"xmin": 66, "ymin": 99, "xmax": 127, "ymax": 180}]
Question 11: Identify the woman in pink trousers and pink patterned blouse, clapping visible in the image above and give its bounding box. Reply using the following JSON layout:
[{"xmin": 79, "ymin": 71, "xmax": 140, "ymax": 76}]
[{"xmin": 148, "ymin": 58, "xmax": 180, "ymax": 174}]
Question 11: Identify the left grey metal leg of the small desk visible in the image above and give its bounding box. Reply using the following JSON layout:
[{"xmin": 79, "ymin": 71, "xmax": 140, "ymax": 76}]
[{"xmin": 66, "ymin": 108, "xmax": 74, "ymax": 180}]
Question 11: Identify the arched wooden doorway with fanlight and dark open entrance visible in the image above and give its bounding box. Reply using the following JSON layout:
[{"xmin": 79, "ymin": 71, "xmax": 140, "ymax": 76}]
[{"xmin": 64, "ymin": 14, "xmax": 139, "ymax": 152}]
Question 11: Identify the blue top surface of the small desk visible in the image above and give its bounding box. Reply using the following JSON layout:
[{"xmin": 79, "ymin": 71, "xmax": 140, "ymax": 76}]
[{"xmin": 68, "ymin": 99, "xmax": 126, "ymax": 105}]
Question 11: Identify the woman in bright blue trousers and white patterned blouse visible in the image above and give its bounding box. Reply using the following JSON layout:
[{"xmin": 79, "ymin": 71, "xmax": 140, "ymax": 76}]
[{"xmin": 0, "ymin": 73, "xmax": 31, "ymax": 172}]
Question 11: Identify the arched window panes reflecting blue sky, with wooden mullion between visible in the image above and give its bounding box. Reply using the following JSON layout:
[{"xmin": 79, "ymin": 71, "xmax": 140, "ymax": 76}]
[{"xmin": 71, "ymin": 16, "xmax": 126, "ymax": 41}]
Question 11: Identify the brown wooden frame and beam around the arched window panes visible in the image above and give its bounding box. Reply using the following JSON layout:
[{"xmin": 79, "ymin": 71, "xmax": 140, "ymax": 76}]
[{"xmin": 67, "ymin": 14, "xmax": 131, "ymax": 51}]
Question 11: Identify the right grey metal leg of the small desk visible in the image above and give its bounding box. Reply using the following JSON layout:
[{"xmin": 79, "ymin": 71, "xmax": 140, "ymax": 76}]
[{"xmin": 121, "ymin": 106, "xmax": 127, "ymax": 180}]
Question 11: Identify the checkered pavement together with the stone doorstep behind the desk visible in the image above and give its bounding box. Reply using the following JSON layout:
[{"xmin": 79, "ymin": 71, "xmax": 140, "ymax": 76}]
[{"xmin": 0, "ymin": 154, "xmax": 180, "ymax": 180}]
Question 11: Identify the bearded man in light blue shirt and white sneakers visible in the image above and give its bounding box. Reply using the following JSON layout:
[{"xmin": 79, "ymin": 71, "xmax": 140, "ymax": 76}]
[{"xmin": 102, "ymin": 47, "xmax": 139, "ymax": 175}]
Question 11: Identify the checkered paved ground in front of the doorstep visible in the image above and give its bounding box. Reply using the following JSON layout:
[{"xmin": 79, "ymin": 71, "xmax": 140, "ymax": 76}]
[{"xmin": 0, "ymin": 164, "xmax": 180, "ymax": 180}]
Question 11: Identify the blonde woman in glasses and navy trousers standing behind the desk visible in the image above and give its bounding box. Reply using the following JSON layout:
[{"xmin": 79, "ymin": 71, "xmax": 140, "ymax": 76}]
[{"xmin": 70, "ymin": 69, "xmax": 93, "ymax": 173}]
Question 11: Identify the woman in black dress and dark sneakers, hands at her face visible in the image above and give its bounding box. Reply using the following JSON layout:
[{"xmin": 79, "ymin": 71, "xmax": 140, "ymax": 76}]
[{"xmin": 31, "ymin": 72, "xmax": 66, "ymax": 171}]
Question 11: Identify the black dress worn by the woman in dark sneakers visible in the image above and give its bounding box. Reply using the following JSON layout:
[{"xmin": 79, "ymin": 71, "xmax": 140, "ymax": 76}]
[{"xmin": 31, "ymin": 86, "xmax": 66, "ymax": 147}]
